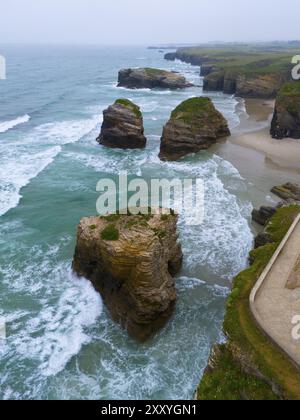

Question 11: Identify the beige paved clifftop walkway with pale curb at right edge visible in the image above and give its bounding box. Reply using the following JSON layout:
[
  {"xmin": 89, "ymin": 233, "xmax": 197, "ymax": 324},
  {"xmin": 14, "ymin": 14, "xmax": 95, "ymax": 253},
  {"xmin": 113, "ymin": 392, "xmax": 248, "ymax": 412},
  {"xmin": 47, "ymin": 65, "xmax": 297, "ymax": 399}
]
[{"xmin": 250, "ymin": 215, "xmax": 300, "ymax": 367}]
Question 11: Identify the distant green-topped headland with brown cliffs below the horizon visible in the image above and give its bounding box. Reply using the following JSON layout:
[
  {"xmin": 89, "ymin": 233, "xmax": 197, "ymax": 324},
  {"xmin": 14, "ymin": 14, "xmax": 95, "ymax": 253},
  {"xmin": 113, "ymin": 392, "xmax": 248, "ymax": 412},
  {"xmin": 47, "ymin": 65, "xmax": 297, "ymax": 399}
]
[{"xmin": 165, "ymin": 46, "xmax": 293, "ymax": 99}]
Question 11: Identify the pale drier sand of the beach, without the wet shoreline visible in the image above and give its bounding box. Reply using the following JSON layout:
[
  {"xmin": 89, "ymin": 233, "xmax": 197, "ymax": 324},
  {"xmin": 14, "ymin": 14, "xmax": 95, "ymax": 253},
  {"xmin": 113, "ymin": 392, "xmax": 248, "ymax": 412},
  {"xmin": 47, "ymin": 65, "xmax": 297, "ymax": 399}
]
[{"xmin": 230, "ymin": 99, "xmax": 300, "ymax": 173}]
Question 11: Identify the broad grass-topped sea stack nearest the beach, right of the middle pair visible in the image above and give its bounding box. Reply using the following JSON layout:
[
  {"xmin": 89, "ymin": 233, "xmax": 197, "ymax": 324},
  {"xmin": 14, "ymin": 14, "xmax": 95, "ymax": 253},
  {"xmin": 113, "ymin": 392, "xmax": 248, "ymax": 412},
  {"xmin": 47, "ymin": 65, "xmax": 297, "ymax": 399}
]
[{"xmin": 159, "ymin": 97, "xmax": 230, "ymax": 160}]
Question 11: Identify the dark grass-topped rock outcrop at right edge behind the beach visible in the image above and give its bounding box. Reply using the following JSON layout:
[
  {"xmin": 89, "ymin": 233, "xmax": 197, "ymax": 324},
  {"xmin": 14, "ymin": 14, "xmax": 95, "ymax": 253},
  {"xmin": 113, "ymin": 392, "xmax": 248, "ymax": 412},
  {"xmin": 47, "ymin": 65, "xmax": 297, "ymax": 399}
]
[{"xmin": 271, "ymin": 82, "xmax": 300, "ymax": 139}]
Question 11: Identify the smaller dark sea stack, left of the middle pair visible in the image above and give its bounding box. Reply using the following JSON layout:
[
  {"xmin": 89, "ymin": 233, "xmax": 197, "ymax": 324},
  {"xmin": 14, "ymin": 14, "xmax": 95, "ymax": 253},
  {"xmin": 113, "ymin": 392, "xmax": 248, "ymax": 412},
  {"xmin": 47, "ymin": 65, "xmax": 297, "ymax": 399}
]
[{"xmin": 97, "ymin": 99, "xmax": 146, "ymax": 149}]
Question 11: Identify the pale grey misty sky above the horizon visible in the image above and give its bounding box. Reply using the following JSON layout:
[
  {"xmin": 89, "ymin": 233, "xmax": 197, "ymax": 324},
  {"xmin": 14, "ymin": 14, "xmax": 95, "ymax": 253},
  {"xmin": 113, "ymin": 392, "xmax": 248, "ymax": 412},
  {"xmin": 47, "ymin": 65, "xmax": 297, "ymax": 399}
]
[{"xmin": 0, "ymin": 0, "xmax": 300, "ymax": 45}]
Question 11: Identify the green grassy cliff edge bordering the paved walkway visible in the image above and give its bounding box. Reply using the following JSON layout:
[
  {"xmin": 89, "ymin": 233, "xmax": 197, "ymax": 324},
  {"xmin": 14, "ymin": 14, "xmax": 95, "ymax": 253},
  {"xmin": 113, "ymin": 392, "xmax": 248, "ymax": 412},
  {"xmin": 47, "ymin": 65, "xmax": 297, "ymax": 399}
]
[{"xmin": 198, "ymin": 206, "xmax": 300, "ymax": 400}]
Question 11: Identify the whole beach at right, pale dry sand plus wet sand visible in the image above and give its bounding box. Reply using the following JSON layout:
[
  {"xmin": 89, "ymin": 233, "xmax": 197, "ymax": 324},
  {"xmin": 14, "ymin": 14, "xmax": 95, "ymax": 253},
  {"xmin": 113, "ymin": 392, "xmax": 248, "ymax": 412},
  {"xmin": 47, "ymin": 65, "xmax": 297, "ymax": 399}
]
[{"xmin": 212, "ymin": 99, "xmax": 300, "ymax": 207}]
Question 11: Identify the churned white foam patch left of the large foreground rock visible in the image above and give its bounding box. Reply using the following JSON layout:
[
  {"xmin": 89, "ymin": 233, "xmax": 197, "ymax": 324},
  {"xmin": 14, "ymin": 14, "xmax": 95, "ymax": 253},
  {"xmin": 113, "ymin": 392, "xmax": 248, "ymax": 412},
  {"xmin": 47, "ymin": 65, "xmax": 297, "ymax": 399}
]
[{"xmin": 0, "ymin": 238, "xmax": 103, "ymax": 380}]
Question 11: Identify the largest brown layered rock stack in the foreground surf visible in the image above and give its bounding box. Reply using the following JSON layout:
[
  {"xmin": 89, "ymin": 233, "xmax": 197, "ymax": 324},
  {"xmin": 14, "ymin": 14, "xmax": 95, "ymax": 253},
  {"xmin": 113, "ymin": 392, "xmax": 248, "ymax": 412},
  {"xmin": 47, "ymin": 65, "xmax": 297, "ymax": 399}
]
[{"xmin": 73, "ymin": 213, "xmax": 182, "ymax": 341}]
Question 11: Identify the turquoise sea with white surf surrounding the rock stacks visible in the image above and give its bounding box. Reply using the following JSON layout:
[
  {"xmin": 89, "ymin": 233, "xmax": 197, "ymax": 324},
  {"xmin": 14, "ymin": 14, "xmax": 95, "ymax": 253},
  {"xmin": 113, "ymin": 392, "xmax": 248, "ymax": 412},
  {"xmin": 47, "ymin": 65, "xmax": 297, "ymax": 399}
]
[{"xmin": 0, "ymin": 47, "xmax": 252, "ymax": 399}]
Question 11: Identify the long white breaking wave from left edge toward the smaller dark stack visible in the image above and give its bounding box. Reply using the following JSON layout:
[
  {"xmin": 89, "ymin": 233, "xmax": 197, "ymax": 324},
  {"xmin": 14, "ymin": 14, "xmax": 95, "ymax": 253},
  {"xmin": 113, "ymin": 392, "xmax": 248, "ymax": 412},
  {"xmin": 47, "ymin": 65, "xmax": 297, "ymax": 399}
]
[{"xmin": 0, "ymin": 115, "xmax": 99, "ymax": 216}]
